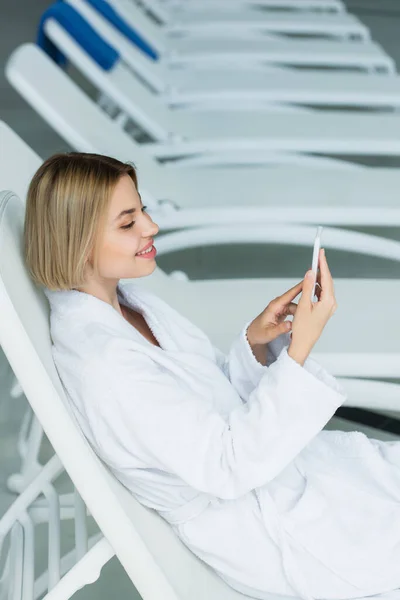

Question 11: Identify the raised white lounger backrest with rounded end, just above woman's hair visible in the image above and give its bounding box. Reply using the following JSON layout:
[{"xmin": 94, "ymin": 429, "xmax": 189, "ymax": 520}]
[{"xmin": 6, "ymin": 44, "xmax": 170, "ymax": 198}]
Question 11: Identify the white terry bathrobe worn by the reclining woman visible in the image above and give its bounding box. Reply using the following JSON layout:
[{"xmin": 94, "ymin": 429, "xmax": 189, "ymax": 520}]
[{"xmin": 46, "ymin": 284, "xmax": 400, "ymax": 599}]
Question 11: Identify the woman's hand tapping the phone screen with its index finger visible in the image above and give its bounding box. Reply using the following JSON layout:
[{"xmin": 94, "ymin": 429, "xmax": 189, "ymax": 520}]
[{"xmin": 247, "ymin": 281, "xmax": 304, "ymax": 364}]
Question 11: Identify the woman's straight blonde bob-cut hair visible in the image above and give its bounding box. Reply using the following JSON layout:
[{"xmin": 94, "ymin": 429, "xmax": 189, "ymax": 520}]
[{"xmin": 24, "ymin": 152, "xmax": 137, "ymax": 290}]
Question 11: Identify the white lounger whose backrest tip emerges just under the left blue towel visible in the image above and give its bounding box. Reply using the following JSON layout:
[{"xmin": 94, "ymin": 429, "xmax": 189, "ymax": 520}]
[{"xmin": 22, "ymin": 27, "xmax": 400, "ymax": 164}]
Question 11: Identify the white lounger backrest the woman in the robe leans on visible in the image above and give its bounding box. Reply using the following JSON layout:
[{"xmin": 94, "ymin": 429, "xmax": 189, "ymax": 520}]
[{"xmin": 0, "ymin": 191, "xmax": 250, "ymax": 600}]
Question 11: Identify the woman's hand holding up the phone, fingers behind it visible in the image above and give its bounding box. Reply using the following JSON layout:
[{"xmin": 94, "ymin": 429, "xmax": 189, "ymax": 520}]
[{"xmin": 288, "ymin": 249, "xmax": 337, "ymax": 365}]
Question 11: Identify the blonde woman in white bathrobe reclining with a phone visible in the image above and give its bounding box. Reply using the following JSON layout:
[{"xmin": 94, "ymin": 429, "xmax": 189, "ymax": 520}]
[{"xmin": 25, "ymin": 153, "xmax": 400, "ymax": 599}]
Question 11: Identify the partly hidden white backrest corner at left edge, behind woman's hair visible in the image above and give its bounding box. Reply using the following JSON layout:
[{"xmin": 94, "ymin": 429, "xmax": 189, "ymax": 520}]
[{"xmin": 0, "ymin": 121, "xmax": 42, "ymax": 201}]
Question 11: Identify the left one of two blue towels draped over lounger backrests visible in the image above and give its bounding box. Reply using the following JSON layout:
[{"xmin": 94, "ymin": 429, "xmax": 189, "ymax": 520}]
[{"xmin": 36, "ymin": 0, "xmax": 119, "ymax": 71}]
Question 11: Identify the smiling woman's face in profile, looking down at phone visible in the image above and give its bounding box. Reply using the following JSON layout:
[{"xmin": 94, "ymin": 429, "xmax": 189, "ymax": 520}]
[{"xmin": 93, "ymin": 175, "xmax": 159, "ymax": 280}]
